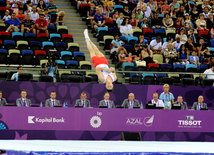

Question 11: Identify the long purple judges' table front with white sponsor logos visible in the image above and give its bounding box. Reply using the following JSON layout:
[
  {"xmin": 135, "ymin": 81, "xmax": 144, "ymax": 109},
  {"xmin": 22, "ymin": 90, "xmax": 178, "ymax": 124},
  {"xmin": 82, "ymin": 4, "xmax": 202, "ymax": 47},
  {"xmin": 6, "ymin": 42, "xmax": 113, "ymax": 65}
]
[{"xmin": 0, "ymin": 107, "xmax": 214, "ymax": 141}]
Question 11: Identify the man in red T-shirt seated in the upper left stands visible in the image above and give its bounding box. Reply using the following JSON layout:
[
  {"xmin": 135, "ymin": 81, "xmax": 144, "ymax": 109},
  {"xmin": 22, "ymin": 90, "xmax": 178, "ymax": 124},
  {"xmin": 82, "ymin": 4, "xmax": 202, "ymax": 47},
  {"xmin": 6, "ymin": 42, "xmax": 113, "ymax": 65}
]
[{"xmin": 35, "ymin": 14, "xmax": 49, "ymax": 35}]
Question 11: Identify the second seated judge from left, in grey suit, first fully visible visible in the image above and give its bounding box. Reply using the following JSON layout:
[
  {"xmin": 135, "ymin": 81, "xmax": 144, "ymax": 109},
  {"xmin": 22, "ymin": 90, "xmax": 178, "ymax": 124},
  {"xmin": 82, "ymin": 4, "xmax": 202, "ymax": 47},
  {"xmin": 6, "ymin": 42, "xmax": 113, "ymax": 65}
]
[{"xmin": 16, "ymin": 90, "xmax": 31, "ymax": 107}]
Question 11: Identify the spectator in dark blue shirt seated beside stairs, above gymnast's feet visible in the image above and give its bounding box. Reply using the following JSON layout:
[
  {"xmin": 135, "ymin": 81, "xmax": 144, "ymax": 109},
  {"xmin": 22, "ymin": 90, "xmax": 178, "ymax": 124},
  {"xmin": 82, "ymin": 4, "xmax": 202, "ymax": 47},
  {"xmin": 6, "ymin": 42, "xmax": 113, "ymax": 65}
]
[{"xmin": 93, "ymin": 7, "xmax": 108, "ymax": 36}]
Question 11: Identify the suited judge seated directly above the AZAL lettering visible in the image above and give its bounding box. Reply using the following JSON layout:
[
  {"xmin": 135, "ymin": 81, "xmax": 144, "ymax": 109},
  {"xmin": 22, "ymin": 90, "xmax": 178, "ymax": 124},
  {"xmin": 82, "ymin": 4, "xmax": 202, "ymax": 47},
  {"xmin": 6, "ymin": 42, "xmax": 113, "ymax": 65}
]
[{"xmin": 122, "ymin": 93, "xmax": 140, "ymax": 109}]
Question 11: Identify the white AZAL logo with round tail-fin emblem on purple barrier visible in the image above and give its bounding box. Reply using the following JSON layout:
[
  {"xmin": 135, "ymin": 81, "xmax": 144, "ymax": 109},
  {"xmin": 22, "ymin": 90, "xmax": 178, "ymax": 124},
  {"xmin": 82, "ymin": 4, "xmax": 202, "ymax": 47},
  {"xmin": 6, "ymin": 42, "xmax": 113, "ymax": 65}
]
[{"xmin": 126, "ymin": 115, "xmax": 154, "ymax": 127}]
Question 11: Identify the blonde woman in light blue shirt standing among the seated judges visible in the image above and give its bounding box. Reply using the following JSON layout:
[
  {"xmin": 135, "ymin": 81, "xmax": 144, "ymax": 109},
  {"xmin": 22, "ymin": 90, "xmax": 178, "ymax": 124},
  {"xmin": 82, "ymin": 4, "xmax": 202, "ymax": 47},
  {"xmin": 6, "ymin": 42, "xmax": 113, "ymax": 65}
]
[{"xmin": 159, "ymin": 84, "xmax": 175, "ymax": 109}]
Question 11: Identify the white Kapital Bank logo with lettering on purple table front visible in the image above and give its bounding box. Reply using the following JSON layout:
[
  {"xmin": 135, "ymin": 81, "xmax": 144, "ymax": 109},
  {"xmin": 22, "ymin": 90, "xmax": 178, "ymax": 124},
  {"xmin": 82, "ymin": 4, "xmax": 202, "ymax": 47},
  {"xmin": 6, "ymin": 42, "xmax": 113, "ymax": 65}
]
[{"xmin": 28, "ymin": 116, "xmax": 65, "ymax": 124}]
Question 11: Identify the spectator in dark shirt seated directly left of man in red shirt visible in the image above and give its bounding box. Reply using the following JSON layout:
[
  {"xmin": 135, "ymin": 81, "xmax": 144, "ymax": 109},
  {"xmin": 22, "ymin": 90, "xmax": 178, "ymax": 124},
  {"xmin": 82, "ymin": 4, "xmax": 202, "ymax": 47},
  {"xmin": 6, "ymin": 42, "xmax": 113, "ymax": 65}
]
[{"xmin": 21, "ymin": 14, "xmax": 36, "ymax": 34}]
